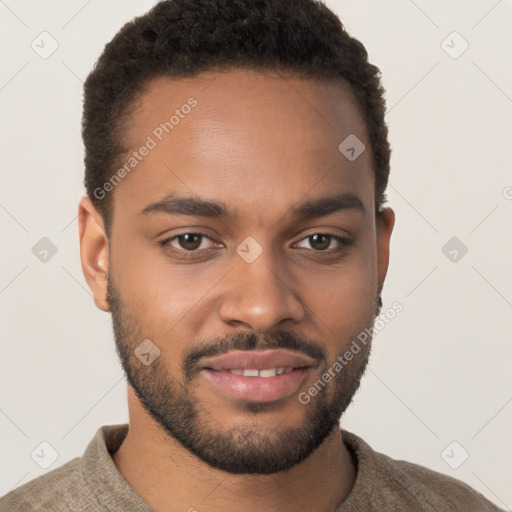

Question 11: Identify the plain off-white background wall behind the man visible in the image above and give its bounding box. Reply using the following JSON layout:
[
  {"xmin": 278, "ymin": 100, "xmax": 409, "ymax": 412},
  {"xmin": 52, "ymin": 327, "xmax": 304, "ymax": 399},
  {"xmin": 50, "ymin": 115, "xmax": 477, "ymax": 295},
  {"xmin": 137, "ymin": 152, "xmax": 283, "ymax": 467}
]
[{"xmin": 0, "ymin": 0, "xmax": 512, "ymax": 509}]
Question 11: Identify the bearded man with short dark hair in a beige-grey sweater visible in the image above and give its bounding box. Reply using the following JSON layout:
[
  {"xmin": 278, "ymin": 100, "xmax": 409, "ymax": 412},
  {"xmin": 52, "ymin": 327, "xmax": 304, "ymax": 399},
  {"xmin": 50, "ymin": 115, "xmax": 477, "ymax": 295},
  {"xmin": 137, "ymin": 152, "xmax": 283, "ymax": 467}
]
[{"xmin": 0, "ymin": 0, "xmax": 499, "ymax": 512}]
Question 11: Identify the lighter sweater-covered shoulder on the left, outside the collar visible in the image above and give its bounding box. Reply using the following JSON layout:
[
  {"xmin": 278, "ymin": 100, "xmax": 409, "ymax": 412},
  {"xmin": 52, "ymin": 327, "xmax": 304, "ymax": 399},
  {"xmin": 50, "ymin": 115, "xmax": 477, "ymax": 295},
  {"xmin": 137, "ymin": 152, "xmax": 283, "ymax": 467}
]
[{"xmin": 0, "ymin": 457, "xmax": 102, "ymax": 512}]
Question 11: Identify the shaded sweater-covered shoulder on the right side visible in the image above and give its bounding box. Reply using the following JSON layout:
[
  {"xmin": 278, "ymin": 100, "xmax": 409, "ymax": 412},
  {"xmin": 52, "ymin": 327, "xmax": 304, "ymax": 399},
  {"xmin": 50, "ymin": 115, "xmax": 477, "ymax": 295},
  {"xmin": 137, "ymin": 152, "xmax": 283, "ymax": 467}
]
[{"xmin": 343, "ymin": 431, "xmax": 503, "ymax": 512}]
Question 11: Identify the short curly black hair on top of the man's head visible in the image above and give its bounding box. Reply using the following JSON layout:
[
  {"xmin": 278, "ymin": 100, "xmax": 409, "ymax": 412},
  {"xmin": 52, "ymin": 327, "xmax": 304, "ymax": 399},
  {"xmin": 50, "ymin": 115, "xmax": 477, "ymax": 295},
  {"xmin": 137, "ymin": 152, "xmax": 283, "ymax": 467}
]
[{"xmin": 82, "ymin": 0, "xmax": 391, "ymax": 238}]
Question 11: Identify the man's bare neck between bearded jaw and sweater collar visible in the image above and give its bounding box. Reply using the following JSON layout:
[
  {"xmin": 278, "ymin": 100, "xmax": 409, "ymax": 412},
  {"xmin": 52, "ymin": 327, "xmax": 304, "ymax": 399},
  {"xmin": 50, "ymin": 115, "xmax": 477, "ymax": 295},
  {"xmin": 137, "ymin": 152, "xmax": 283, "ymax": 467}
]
[{"xmin": 113, "ymin": 390, "xmax": 356, "ymax": 512}]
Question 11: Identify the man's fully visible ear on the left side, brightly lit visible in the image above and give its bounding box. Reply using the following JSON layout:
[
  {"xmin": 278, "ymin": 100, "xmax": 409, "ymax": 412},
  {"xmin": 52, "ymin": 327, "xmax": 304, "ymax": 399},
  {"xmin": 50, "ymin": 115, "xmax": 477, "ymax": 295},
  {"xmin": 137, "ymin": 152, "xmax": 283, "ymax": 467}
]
[{"xmin": 78, "ymin": 196, "xmax": 110, "ymax": 312}]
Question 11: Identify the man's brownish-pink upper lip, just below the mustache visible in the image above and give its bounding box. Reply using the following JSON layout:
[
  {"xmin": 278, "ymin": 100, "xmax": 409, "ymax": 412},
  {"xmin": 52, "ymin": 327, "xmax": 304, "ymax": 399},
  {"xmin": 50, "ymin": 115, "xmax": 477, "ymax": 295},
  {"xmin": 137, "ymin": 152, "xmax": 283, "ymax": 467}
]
[{"xmin": 202, "ymin": 349, "xmax": 315, "ymax": 370}]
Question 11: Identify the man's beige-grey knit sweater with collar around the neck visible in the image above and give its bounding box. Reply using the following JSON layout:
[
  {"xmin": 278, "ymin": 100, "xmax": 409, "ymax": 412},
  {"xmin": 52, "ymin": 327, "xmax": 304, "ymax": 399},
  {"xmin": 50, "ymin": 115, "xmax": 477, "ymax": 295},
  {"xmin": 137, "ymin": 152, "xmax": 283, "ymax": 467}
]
[{"xmin": 0, "ymin": 424, "xmax": 502, "ymax": 512}]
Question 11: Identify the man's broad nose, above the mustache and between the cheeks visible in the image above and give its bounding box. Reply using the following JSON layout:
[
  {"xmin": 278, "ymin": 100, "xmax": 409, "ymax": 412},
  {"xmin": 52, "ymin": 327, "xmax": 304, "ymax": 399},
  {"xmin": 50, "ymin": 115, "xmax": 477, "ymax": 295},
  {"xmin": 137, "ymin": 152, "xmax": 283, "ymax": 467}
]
[{"xmin": 219, "ymin": 243, "xmax": 305, "ymax": 333}]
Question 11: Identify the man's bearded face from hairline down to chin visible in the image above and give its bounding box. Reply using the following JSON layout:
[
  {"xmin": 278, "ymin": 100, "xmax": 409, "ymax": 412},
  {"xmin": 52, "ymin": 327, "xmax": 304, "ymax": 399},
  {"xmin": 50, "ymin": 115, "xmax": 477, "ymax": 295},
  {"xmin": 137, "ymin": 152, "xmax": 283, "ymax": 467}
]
[{"xmin": 80, "ymin": 70, "xmax": 394, "ymax": 474}]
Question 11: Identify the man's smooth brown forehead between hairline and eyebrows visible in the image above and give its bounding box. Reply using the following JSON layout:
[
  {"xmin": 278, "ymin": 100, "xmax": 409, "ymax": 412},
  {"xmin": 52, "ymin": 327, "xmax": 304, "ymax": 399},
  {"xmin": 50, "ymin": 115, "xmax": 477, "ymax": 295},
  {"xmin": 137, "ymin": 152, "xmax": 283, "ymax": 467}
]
[{"xmin": 114, "ymin": 70, "xmax": 374, "ymax": 226}]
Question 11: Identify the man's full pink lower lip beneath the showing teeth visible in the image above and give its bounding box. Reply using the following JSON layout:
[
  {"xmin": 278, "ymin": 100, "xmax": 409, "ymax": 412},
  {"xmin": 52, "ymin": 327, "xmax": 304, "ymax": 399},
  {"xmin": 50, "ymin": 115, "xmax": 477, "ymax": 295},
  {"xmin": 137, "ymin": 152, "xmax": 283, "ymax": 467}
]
[{"xmin": 203, "ymin": 368, "xmax": 308, "ymax": 402}]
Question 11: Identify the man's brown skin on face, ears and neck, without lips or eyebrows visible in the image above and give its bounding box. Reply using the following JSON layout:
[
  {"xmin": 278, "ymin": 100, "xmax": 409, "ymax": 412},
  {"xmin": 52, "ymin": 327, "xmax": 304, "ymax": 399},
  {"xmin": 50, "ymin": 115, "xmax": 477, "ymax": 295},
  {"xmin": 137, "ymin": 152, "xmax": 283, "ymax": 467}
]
[{"xmin": 79, "ymin": 70, "xmax": 395, "ymax": 512}]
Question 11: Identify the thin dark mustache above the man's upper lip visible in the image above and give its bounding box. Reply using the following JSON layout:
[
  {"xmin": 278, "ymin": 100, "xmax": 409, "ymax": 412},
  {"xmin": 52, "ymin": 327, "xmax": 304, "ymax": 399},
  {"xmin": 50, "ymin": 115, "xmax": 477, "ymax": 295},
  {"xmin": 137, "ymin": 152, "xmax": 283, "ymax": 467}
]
[{"xmin": 182, "ymin": 331, "xmax": 327, "ymax": 380}]
